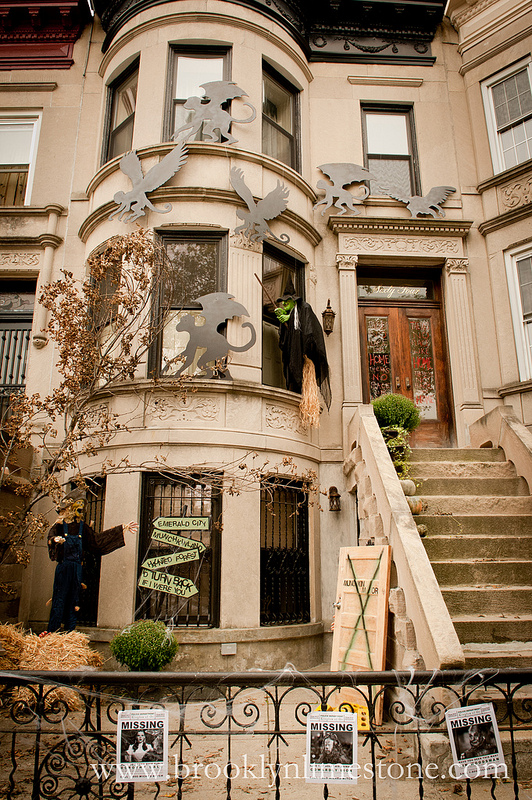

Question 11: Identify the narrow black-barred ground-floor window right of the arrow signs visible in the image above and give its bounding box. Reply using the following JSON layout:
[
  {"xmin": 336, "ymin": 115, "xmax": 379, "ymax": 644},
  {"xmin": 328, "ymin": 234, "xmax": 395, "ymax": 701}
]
[{"xmin": 260, "ymin": 480, "xmax": 310, "ymax": 625}]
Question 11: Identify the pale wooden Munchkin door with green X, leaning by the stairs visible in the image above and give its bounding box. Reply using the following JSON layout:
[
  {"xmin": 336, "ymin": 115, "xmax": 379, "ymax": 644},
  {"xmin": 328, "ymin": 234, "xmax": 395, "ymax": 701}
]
[{"xmin": 331, "ymin": 545, "xmax": 391, "ymax": 724}]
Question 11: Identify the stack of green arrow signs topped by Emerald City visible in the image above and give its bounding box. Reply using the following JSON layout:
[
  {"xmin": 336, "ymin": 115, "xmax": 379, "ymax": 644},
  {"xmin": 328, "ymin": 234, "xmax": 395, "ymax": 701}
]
[{"xmin": 139, "ymin": 517, "xmax": 210, "ymax": 598}]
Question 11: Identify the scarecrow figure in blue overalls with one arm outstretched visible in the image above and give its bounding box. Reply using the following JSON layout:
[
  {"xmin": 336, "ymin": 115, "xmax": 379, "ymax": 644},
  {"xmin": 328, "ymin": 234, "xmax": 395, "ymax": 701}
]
[{"xmin": 40, "ymin": 489, "xmax": 138, "ymax": 636}]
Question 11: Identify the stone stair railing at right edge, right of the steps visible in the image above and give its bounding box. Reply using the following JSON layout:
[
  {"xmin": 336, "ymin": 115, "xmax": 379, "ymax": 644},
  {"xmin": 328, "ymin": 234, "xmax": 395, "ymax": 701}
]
[{"xmin": 469, "ymin": 406, "xmax": 532, "ymax": 493}]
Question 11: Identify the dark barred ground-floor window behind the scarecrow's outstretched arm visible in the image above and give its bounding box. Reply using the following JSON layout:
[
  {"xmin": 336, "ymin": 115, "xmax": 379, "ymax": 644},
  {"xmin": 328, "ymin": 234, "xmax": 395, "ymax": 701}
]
[{"xmin": 76, "ymin": 478, "xmax": 105, "ymax": 626}]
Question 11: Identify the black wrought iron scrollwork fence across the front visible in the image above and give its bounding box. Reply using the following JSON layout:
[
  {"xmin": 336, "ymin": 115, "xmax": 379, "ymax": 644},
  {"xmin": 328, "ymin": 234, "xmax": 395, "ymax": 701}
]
[{"xmin": 0, "ymin": 668, "xmax": 532, "ymax": 800}]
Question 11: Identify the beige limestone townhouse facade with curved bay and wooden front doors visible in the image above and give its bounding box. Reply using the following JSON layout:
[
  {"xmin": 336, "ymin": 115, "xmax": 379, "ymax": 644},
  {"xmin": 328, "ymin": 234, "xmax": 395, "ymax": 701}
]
[{"xmin": 0, "ymin": 0, "xmax": 532, "ymax": 669}]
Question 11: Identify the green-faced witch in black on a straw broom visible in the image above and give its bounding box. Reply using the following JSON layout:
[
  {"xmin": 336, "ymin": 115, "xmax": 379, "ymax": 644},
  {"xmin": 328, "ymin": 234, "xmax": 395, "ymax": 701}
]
[{"xmin": 275, "ymin": 281, "xmax": 331, "ymax": 428}]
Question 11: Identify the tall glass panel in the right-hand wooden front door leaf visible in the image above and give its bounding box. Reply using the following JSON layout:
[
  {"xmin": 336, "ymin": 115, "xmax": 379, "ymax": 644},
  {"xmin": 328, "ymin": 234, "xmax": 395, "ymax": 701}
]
[{"xmin": 408, "ymin": 317, "xmax": 438, "ymax": 419}]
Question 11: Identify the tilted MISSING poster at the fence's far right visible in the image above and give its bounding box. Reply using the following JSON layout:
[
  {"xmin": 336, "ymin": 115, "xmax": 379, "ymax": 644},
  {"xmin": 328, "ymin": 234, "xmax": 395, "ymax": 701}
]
[{"xmin": 445, "ymin": 703, "xmax": 506, "ymax": 778}]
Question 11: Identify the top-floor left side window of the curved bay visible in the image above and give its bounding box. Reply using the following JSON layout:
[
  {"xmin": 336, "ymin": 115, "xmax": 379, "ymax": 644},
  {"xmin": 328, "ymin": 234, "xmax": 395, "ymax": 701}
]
[{"xmin": 102, "ymin": 60, "xmax": 139, "ymax": 164}]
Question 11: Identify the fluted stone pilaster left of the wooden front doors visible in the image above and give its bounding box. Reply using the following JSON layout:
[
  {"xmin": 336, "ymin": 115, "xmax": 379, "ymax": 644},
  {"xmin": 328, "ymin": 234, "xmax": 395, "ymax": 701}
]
[{"xmin": 336, "ymin": 253, "xmax": 362, "ymax": 457}]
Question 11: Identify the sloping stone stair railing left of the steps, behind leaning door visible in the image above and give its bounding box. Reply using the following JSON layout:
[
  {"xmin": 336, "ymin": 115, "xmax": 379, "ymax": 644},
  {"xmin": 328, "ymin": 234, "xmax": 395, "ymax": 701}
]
[{"xmin": 344, "ymin": 405, "xmax": 465, "ymax": 669}]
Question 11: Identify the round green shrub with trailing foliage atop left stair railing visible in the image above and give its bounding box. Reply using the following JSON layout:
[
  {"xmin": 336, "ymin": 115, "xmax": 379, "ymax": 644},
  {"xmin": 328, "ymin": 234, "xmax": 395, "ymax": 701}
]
[{"xmin": 372, "ymin": 394, "xmax": 420, "ymax": 479}]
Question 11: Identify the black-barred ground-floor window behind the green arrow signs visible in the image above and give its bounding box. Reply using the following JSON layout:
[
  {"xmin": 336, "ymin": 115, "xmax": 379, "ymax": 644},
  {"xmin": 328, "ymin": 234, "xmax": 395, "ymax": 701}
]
[{"xmin": 136, "ymin": 474, "xmax": 222, "ymax": 628}]
